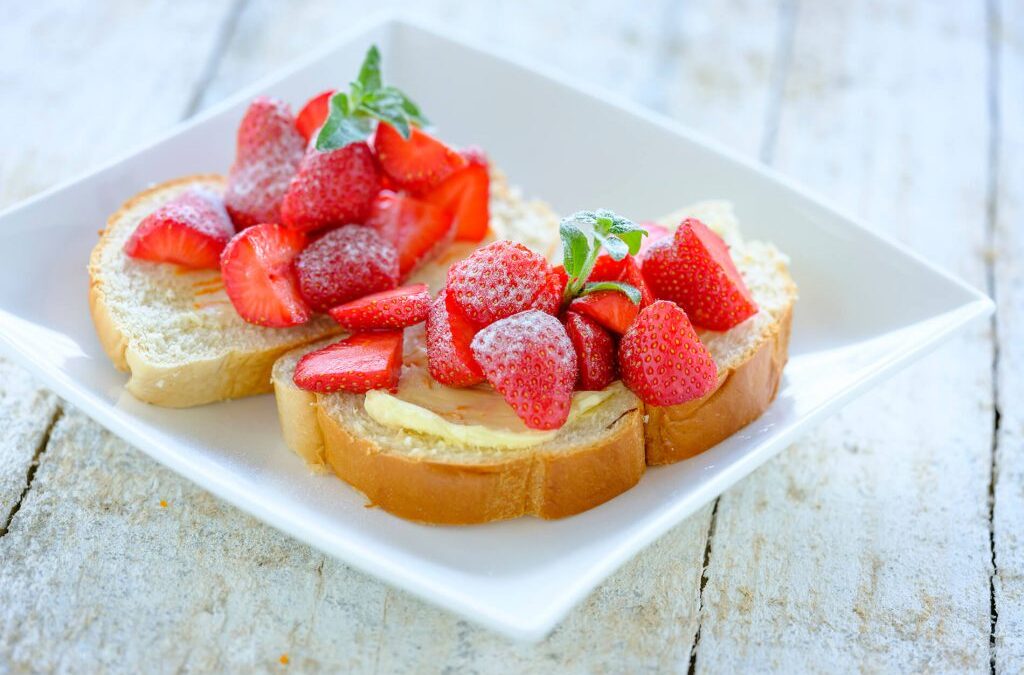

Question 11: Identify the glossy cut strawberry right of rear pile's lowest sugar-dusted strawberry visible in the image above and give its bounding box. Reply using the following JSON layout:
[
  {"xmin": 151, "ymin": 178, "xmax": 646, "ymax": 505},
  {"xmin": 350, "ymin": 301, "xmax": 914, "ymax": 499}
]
[{"xmin": 367, "ymin": 189, "xmax": 455, "ymax": 279}]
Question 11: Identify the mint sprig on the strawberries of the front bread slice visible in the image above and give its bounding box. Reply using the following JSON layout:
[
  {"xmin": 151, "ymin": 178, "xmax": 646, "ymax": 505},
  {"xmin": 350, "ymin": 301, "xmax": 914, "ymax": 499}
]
[{"xmin": 558, "ymin": 209, "xmax": 647, "ymax": 304}]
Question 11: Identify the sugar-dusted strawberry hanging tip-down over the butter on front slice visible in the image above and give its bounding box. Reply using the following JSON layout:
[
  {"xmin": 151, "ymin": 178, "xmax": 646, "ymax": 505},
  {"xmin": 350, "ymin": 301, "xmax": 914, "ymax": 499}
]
[{"xmin": 471, "ymin": 309, "xmax": 577, "ymax": 429}]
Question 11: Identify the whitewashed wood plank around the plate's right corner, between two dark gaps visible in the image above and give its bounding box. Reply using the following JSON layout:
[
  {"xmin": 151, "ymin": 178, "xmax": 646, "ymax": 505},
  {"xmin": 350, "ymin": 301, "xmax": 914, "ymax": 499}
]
[{"xmin": 696, "ymin": 2, "xmax": 995, "ymax": 672}]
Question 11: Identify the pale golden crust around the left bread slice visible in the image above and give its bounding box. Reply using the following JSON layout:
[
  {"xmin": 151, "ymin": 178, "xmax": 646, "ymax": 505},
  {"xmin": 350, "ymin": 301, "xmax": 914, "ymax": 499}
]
[{"xmin": 89, "ymin": 174, "xmax": 341, "ymax": 408}]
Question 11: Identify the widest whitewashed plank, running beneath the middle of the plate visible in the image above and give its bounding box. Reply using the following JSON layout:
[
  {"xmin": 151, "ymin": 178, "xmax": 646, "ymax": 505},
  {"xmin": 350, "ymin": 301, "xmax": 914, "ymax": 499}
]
[{"xmin": 0, "ymin": 1, "xmax": 775, "ymax": 671}]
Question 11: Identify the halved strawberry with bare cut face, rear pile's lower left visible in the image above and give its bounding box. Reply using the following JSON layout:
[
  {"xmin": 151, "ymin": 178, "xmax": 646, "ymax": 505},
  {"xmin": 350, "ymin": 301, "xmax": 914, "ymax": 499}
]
[{"xmin": 220, "ymin": 223, "xmax": 310, "ymax": 328}]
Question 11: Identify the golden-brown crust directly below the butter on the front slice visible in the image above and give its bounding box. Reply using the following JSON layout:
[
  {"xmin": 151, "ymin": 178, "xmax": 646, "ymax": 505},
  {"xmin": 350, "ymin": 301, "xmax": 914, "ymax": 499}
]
[{"xmin": 317, "ymin": 402, "xmax": 646, "ymax": 524}]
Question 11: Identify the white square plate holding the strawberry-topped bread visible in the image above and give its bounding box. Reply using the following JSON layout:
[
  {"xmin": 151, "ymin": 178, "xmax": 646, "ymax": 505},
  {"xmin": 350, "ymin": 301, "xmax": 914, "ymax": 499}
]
[{"xmin": 0, "ymin": 14, "xmax": 992, "ymax": 639}]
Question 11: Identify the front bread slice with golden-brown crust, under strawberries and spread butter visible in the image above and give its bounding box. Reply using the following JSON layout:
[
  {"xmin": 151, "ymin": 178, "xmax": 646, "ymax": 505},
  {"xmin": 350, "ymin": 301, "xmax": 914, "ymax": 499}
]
[{"xmin": 273, "ymin": 200, "xmax": 796, "ymax": 523}]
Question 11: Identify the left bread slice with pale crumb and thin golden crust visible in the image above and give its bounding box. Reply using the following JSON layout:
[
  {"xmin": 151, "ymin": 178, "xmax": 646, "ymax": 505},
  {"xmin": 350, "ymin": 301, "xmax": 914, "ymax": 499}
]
[{"xmin": 89, "ymin": 175, "xmax": 340, "ymax": 408}]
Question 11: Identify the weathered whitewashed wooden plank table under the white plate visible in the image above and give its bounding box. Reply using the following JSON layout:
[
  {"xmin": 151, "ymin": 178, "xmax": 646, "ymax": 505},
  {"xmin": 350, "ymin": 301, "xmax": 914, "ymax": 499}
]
[{"xmin": 0, "ymin": 0, "xmax": 1024, "ymax": 673}]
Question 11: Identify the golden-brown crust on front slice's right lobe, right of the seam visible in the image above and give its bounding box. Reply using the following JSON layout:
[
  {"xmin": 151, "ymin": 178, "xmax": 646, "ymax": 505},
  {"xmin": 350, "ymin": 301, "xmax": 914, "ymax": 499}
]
[{"xmin": 645, "ymin": 305, "xmax": 793, "ymax": 466}]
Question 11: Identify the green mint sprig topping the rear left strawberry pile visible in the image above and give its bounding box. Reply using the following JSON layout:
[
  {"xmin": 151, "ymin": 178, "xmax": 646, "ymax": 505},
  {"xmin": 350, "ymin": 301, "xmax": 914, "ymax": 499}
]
[{"xmin": 316, "ymin": 45, "xmax": 427, "ymax": 152}]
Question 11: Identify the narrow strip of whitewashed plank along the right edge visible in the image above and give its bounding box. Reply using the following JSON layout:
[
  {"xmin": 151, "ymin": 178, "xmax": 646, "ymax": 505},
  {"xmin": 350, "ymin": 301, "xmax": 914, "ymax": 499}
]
[{"xmin": 992, "ymin": 2, "xmax": 1024, "ymax": 673}]
